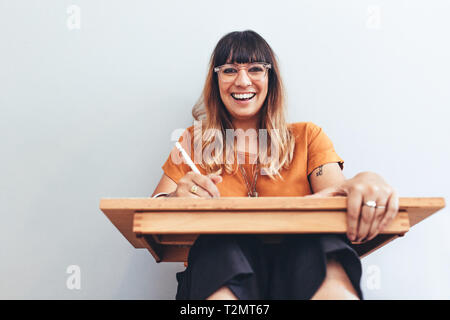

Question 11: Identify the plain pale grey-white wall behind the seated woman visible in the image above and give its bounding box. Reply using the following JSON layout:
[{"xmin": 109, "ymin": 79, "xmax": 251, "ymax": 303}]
[{"xmin": 0, "ymin": 0, "xmax": 450, "ymax": 299}]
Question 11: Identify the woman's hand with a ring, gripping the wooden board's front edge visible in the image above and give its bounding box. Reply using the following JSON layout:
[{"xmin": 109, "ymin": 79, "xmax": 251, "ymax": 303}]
[{"xmin": 308, "ymin": 172, "xmax": 399, "ymax": 242}]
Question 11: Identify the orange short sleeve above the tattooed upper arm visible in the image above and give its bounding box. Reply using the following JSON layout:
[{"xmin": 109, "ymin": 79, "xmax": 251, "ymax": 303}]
[{"xmin": 307, "ymin": 122, "xmax": 344, "ymax": 175}]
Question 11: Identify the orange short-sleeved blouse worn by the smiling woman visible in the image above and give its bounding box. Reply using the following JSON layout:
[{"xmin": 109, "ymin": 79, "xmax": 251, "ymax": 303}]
[{"xmin": 162, "ymin": 122, "xmax": 344, "ymax": 197}]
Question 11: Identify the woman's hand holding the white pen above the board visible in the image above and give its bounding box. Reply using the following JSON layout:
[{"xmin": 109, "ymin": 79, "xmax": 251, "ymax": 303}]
[{"xmin": 170, "ymin": 171, "xmax": 222, "ymax": 198}]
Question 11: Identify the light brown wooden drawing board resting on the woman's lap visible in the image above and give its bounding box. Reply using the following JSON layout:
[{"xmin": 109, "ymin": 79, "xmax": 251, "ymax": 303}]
[{"xmin": 100, "ymin": 197, "xmax": 445, "ymax": 262}]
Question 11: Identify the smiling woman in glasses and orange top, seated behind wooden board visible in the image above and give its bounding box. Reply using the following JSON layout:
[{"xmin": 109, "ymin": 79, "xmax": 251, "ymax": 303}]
[{"xmin": 153, "ymin": 30, "xmax": 398, "ymax": 299}]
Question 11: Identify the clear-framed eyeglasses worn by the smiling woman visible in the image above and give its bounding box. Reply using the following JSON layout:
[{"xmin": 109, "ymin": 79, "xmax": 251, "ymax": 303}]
[{"xmin": 214, "ymin": 62, "xmax": 272, "ymax": 82}]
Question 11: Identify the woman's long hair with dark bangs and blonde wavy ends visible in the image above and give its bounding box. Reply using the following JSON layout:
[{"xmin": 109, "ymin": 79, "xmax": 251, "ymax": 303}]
[{"xmin": 192, "ymin": 30, "xmax": 295, "ymax": 180}]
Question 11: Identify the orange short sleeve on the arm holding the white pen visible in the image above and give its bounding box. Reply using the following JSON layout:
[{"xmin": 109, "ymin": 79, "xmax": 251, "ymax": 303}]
[{"xmin": 162, "ymin": 128, "xmax": 192, "ymax": 184}]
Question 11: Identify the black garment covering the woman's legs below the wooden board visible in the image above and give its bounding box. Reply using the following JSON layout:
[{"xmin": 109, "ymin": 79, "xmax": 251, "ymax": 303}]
[{"xmin": 176, "ymin": 234, "xmax": 363, "ymax": 300}]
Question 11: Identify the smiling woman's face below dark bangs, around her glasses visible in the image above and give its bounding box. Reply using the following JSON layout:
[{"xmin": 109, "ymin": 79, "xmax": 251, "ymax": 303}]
[{"xmin": 218, "ymin": 64, "xmax": 269, "ymax": 121}]
